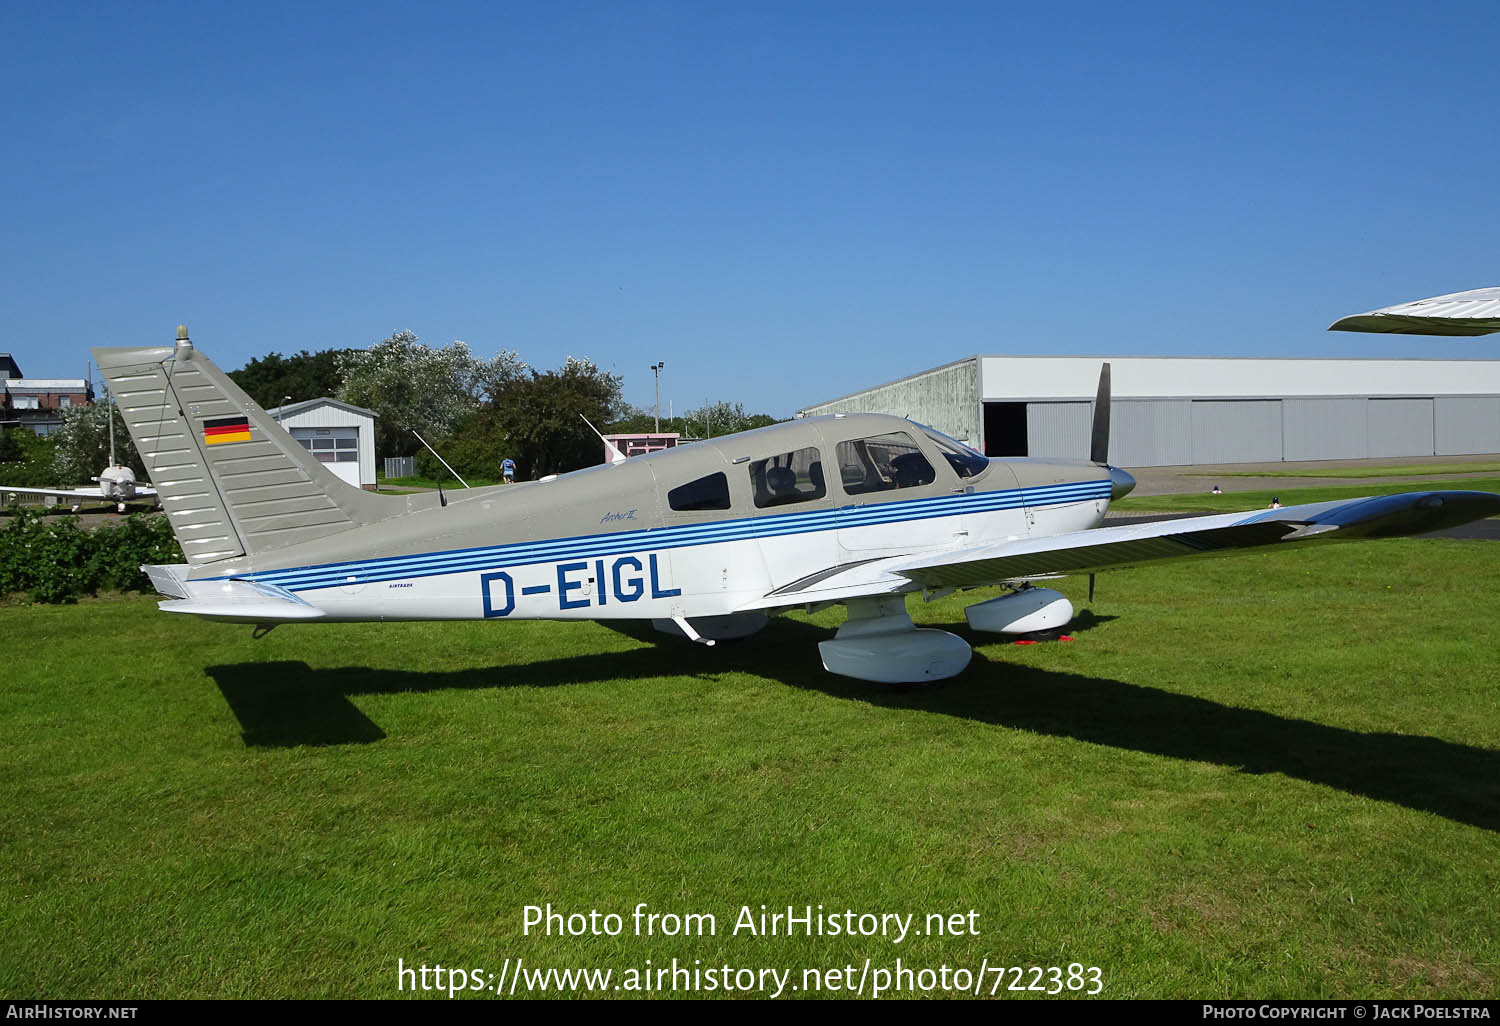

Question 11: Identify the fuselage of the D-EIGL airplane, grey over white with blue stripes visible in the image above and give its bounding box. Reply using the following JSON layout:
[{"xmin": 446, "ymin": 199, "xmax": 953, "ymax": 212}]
[{"xmin": 192, "ymin": 414, "xmax": 1112, "ymax": 620}]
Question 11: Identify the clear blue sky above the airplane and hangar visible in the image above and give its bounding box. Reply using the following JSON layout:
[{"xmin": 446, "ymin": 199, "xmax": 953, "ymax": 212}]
[{"xmin": 0, "ymin": 0, "xmax": 1500, "ymax": 416}]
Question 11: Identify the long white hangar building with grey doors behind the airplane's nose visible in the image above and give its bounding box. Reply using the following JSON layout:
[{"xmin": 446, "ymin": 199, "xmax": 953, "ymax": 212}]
[{"xmin": 798, "ymin": 356, "xmax": 1500, "ymax": 467}]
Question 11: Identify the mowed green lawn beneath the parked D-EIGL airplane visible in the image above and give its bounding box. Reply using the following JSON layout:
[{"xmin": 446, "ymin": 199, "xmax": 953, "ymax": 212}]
[{"xmin": 0, "ymin": 540, "xmax": 1500, "ymax": 998}]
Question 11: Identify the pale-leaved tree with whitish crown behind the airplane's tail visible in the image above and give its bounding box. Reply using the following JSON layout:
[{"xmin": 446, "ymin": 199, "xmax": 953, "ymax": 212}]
[{"xmin": 338, "ymin": 332, "xmax": 527, "ymax": 456}]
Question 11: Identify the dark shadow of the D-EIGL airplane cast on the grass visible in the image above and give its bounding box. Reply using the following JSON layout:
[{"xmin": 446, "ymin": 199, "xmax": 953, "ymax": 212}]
[{"xmin": 207, "ymin": 614, "xmax": 1500, "ymax": 833}]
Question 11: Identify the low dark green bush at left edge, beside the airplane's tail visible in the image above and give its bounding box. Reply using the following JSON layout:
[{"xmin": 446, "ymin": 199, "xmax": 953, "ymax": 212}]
[{"xmin": 0, "ymin": 512, "xmax": 183, "ymax": 602}]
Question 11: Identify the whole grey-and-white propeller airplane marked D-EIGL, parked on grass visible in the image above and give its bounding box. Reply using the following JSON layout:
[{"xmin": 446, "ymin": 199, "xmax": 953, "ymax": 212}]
[{"xmin": 93, "ymin": 294, "xmax": 1500, "ymax": 684}]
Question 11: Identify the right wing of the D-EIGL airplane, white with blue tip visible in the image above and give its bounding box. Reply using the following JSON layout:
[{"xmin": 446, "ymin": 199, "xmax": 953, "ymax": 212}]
[{"xmin": 744, "ymin": 492, "xmax": 1500, "ymax": 609}]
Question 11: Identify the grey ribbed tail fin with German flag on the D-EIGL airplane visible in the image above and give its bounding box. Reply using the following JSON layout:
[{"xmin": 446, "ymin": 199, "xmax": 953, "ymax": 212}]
[{"xmin": 93, "ymin": 327, "xmax": 401, "ymax": 569}]
